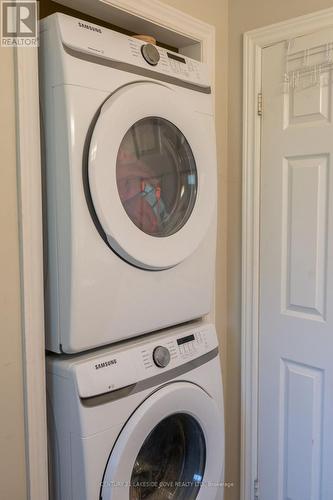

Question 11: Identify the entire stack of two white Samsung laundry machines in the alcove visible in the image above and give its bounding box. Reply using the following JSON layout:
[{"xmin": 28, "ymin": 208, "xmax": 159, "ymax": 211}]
[{"xmin": 40, "ymin": 14, "xmax": 224, "ymax": 500}]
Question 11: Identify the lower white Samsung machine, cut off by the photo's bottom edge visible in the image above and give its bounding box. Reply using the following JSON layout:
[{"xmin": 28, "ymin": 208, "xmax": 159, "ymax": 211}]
[{"xmin": 47, "ymin": 323, "xmax": 224, "ymax": 500}]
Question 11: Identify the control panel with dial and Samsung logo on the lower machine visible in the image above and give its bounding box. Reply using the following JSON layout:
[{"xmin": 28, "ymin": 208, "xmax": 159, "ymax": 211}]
[{"xmin": 72, "ymin": 324, "xmax": 218, "ymax": 398}]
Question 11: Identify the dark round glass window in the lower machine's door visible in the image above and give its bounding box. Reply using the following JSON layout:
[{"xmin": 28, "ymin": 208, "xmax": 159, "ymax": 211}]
[{"xmin": 129, "ymin": 413, "xmax": 206, "ymax": 500}]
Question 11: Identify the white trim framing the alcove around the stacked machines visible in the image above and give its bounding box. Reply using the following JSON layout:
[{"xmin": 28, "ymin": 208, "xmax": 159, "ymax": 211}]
[{"xmin": 14, "ymin": 0, "xmax": 215, "ymax": 500}]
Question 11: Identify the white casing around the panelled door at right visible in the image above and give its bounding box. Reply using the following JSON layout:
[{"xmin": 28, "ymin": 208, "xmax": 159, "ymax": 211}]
[{"xmin": 241, "ymin": 8, "xmax": 333, "ymax": 500}]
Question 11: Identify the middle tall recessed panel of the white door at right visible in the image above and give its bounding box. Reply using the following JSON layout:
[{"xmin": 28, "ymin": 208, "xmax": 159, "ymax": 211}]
[{"xmin": 281, "ymin": 154, "xmax": 330, "ymax": 321}]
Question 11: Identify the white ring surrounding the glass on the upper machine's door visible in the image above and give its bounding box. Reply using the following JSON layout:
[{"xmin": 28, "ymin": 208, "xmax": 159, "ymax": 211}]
[{"xmin": 89, "ymin": 82, "xmax": 216, "ymax": 269}]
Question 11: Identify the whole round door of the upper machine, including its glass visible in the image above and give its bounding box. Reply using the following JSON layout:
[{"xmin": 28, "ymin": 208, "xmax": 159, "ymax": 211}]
[{"xmin": 88, "ymin": 82, "xmax": 216, "ymax": 269}]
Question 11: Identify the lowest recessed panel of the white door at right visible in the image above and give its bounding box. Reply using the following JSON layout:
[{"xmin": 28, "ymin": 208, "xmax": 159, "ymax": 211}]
[{"xmin": 279, "ymin": 359, "xmax": 324, "ymax": 500}]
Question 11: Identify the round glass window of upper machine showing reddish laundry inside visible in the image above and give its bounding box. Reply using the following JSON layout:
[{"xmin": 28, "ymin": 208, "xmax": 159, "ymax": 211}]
[{"xmin": 116, "ymin": 117, "xmax": 197, "ymax": 237}]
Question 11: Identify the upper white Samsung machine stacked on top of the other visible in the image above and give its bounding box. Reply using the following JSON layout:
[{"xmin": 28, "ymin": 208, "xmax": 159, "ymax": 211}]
[{"xmin": 40, "ymin": 14, "xmax": 216, "ymax": 353}]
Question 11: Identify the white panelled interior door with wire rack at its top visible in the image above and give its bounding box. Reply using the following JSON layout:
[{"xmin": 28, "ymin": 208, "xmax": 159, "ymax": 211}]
[{"xmin": 258, "ymin": 29, "xmax": 333, "ymax": 500}]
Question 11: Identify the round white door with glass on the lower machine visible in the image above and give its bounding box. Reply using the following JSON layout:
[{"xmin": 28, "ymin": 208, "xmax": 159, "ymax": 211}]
[{"xmin": 101, "ymin": 382, "xmax": 224, "ymax": 500}]
